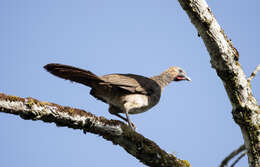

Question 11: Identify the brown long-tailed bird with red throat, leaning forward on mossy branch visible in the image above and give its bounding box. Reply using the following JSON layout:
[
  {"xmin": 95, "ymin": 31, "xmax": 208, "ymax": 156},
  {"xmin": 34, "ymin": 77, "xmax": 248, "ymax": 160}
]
[{"xmin": 44, "ymin": 63, "xmax": 191, "ymax": 129}]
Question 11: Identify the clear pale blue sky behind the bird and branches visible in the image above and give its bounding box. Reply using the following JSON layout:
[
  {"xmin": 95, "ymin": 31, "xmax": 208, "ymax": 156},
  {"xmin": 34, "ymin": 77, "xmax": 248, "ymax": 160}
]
[{"xmin": 0, "ymin": 0, "xmax": 260, "ymax": 167}]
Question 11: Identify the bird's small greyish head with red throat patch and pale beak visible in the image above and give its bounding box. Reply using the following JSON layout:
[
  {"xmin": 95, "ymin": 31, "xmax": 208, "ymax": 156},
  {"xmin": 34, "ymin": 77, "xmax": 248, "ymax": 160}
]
[{"xmin": 165, "ymin": 66, "xmax": 191, "ymax": 81}]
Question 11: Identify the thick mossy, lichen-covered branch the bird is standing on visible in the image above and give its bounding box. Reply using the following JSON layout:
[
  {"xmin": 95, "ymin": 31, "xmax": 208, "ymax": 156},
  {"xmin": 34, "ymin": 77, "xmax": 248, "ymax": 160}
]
[{"xmin": 0, "ymin": 93, "xmax": 190, "ymax": 167}]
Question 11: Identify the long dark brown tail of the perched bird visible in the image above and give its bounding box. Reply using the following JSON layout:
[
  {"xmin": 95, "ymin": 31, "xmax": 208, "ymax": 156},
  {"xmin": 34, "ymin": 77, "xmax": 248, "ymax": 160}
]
[{"xmin": 44, "ymin": 63, "xmax": 104, "ymax": 87}]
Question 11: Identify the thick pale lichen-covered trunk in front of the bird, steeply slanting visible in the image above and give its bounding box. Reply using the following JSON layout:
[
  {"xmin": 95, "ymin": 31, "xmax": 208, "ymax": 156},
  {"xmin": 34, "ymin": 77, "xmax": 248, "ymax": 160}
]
[{"xmin": 179, "ymin": 0, "xmax": 260, "ymax": 167}]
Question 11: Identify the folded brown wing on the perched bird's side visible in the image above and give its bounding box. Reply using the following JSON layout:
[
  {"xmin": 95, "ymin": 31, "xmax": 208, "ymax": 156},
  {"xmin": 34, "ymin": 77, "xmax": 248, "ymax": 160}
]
[{"xmin": 101, "ymin": 74, "xmax": 159, "ymax": 95}]
